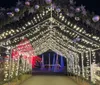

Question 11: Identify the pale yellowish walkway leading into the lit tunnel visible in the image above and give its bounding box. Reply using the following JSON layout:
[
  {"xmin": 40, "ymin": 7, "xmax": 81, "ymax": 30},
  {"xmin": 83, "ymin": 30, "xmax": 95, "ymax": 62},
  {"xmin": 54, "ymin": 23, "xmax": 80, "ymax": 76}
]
[{"xmin": 21, "ymin": 75, "xmax": 77, "ymax": 85}]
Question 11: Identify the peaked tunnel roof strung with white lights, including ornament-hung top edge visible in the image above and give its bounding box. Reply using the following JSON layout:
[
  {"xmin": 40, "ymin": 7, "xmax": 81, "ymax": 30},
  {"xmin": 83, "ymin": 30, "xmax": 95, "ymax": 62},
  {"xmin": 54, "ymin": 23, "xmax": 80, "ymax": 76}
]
[{"xmin": 0, "ymin": 0, "xmax": 100, "ymax": 56}]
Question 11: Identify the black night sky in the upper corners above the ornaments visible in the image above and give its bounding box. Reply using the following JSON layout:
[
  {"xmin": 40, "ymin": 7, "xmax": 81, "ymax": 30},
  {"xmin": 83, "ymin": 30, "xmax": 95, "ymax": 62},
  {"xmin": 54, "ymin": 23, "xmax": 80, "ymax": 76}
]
[{"xmin": 0, "ymin": 0, "xmax": 100, "ymax": 15}]
